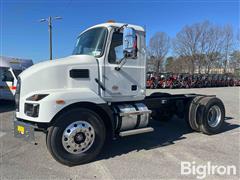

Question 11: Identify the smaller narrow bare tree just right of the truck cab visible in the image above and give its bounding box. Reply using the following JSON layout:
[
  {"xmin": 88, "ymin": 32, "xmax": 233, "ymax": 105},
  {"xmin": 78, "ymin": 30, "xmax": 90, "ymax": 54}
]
[{"xmin": 149, "ymin": 32, "xmax": 170, "ymax": 74}]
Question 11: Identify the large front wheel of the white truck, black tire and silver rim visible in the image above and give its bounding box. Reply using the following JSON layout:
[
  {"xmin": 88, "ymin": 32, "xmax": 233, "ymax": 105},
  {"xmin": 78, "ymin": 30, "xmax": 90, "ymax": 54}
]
[{"xmin": 46, "ymin": 108, "xmax": 106, "ymax": 166}]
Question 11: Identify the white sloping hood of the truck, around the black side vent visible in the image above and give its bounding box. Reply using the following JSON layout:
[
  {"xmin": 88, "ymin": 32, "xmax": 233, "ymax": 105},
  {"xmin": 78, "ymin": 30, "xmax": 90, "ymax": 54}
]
[{"xmin": 19, "ymin": 55, "xmax": 98, "ymax": 96}]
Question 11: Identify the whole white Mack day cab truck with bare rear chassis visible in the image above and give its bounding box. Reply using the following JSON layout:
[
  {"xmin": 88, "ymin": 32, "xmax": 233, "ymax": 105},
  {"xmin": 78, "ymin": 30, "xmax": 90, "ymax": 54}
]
[{"xmin": 14, "ymin": 22, "xmax": 225, "ymax": 166}]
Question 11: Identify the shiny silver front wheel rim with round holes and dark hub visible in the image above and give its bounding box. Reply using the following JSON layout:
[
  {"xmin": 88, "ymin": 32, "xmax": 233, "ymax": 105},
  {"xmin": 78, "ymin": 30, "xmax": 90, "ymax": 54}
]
[{"xmin": 62, "ymin": 121, "xmax": 95, "ymax": 154}]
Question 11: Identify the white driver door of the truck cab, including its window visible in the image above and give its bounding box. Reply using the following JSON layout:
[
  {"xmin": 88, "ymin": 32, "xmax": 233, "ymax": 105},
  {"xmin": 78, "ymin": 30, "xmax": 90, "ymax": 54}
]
[{"xmin": 103, "ymin": 31, "xmax": 145, "ymax": 101}]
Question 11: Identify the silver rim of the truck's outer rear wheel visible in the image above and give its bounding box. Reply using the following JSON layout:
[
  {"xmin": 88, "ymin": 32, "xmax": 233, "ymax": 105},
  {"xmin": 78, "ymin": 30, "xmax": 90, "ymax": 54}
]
[{"xmin": 207, "ymin": 105, "xmax": 222, "ymax": 128}]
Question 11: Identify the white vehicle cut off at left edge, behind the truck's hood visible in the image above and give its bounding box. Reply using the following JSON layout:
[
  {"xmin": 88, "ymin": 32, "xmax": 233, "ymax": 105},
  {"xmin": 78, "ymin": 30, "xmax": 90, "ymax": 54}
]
[{"xmin": 0, "ymin": 56, "xmax": 33, "ymax": 100}]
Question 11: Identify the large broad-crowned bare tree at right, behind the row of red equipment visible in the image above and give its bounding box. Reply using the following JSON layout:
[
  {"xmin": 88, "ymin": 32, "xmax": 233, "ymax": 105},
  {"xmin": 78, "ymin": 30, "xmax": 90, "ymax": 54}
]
[{"xmin": 173, "ymin": 21, "xmax": 227, "ymax": 73}]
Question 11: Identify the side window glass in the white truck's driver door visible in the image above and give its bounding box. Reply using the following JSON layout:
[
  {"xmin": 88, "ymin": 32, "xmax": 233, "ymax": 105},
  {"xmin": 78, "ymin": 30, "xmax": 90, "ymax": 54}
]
[{"xmin": 108, "ymin": 32, "xmax": 123, "ymax": 64}]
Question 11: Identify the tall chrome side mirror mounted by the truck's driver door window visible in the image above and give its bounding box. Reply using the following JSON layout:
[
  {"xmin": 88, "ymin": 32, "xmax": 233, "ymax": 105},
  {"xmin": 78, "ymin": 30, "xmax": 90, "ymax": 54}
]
[{"xmin": 123, "ymin": 27, "xmax": 137, "ymax": 58}]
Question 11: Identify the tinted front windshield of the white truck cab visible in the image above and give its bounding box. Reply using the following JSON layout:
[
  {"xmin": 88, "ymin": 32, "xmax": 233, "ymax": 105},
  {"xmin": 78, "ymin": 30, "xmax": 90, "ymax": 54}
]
[{"xmin": 73, "ymin": 27, "xmax": 107, "ymax": 57}]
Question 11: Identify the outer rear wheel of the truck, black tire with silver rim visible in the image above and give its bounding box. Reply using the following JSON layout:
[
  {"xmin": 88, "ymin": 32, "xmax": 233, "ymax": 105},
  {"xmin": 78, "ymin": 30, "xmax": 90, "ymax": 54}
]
[{"xmin": 199, "ymin": 97, "xmax": 225, "ymax": 134}]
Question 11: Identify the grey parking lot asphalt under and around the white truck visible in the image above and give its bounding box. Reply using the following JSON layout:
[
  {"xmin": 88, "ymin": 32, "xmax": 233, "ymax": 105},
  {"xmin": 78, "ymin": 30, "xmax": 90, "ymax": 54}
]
[{"xmin": 0, "ymin": 87, "xmax": 240, "ymax": 180}]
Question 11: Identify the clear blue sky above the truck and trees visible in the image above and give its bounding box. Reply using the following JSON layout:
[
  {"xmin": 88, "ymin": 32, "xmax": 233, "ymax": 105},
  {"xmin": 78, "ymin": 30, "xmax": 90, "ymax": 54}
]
[{"xmin": 0, "ymin": 0, "xmax": 240, "ymax": 63}]
